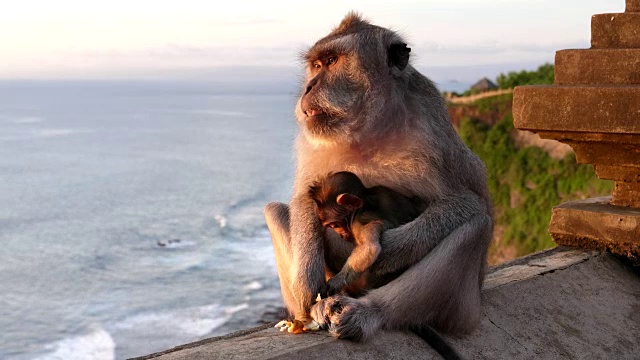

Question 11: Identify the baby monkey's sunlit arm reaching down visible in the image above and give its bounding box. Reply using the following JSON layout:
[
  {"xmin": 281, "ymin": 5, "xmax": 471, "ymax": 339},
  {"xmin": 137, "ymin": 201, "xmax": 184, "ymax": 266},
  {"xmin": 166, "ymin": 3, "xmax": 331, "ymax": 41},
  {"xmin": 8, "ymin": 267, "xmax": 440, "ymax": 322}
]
[{"xmin": 327, "ymin": 220, "xmax": 384, "ymax": 295}]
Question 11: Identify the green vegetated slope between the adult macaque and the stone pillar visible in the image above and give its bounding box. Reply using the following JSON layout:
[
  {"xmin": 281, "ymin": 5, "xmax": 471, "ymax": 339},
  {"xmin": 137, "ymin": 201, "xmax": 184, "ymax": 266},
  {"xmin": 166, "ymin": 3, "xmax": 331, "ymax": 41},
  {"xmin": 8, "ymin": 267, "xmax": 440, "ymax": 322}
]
[{"xmin": 458, "ymin": 93, "xmax": 612, "ymax": 262}]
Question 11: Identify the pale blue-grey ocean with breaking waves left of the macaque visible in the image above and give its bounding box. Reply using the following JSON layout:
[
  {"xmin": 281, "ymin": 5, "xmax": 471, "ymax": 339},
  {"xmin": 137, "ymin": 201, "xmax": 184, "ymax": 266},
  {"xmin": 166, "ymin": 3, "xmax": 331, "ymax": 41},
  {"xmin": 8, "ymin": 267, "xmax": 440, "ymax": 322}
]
[{"xmin": 0, "ymin": 81, "xmax": 296, "ymax": 360}]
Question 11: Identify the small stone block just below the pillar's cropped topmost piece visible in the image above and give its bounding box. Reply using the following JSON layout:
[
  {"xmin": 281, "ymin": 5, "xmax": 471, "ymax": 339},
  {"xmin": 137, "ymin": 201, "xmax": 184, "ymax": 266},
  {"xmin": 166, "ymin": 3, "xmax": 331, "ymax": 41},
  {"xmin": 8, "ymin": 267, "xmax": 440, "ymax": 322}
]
[{"xmin": 591, "ymin": 12, "xmax": 640, "ymax": 49}]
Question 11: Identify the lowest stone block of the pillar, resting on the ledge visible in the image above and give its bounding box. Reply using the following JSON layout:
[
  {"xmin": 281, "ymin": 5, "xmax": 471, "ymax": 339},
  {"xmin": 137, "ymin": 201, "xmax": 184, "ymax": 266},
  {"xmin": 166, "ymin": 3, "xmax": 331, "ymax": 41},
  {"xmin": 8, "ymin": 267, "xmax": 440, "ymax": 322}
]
[{"xmin": 549, "ymin": 197, "xmax": 640, "ymax": 261}]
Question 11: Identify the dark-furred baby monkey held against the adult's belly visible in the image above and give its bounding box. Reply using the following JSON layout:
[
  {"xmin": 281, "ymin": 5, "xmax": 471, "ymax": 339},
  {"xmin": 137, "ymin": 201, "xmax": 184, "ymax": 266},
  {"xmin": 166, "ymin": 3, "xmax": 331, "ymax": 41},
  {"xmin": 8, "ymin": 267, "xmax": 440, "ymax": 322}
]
[{"xmin": 309, "ymin": 171, "xmax": 424, "ymax": 296}]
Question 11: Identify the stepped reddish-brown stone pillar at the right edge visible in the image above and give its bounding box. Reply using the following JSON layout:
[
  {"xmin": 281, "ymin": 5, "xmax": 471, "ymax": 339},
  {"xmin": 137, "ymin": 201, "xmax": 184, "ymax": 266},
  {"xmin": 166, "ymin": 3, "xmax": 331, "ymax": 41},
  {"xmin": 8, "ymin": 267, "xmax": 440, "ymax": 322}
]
[{"xmin": 513, "ymin": 0, "xmax": 640, "ymax": 261}]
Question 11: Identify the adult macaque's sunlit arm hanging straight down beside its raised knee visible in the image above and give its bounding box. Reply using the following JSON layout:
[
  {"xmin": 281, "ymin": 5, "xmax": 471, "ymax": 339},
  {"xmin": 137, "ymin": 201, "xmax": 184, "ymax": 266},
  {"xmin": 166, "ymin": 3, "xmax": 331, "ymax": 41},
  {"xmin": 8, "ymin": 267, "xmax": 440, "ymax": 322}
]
[{"xmin": 288, "ymin": 191, "xmax": 326, "ymax": 320}]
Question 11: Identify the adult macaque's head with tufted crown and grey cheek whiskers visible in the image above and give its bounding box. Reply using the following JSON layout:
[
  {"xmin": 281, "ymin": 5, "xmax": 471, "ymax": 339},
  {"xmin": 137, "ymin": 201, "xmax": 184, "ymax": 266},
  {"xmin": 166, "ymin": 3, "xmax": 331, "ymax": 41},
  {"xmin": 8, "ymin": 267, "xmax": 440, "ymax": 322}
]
[{"xmin": 296, "ymin": 17, "xmax": 410, "ymax": 144}]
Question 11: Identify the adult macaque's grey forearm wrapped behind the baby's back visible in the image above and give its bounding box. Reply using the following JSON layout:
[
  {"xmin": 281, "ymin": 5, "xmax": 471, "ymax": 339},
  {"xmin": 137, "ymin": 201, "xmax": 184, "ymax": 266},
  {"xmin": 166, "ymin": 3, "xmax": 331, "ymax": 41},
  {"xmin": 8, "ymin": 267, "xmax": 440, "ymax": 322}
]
[{"xmin": 371, "ymin": 190, "xmax": 490, "ymax": 275}]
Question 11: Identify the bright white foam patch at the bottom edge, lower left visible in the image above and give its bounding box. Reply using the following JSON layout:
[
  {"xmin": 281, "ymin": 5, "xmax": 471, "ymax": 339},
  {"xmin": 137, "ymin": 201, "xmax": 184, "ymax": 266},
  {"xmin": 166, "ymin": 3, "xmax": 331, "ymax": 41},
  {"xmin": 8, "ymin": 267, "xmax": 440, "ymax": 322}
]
[{"xmin": 34, "ymin": 325, "xmax": 116, "ymax": 360}]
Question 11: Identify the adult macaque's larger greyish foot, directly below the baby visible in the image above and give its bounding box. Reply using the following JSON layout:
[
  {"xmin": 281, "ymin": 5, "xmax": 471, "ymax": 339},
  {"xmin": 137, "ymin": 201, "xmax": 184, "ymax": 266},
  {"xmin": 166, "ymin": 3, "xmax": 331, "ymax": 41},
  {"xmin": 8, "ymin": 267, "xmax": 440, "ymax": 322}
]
[{"xmin": 311, "ymin": 295, "xmax": 381, "ymax": 341}]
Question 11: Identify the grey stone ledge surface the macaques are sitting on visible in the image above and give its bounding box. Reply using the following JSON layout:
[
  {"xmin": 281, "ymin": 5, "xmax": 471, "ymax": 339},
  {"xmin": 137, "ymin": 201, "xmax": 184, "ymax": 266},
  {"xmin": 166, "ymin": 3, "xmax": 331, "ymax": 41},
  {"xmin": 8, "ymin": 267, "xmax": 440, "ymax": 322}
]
[{"xmin": 130, "ymin": 247, "xmax": 640, "ymax": 360}]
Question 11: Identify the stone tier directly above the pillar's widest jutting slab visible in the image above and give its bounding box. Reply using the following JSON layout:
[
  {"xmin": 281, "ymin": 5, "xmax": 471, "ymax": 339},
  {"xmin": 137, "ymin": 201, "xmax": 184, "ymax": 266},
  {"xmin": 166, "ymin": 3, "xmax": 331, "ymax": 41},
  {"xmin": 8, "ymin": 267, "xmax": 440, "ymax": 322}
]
[{"xmin": 555, "ymin": 49, "xmax": 640, "ymax": 85}]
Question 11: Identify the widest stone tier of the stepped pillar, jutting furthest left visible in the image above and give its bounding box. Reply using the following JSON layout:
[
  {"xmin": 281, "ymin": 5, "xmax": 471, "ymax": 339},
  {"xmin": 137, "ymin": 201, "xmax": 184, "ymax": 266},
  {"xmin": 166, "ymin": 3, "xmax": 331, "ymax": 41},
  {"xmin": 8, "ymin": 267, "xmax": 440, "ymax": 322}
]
[{"xmin": 513, "ymin": 86, "xmax": 640, "ymax": 135}]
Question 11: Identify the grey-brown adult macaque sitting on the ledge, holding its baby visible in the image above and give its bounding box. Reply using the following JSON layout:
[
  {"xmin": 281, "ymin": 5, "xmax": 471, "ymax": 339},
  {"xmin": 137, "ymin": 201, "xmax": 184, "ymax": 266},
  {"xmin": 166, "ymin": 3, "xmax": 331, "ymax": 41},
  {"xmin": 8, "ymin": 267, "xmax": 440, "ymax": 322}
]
[{"xmin": 265, "ymin": 13, "xmax": 492, "ymax": 340}]
